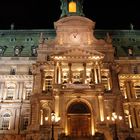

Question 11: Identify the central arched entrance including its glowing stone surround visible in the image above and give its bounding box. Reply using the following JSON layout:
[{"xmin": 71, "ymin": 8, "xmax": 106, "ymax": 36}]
[{"xmin": 65, "ymin": 98, "xmax": 95, "ymax": 137}]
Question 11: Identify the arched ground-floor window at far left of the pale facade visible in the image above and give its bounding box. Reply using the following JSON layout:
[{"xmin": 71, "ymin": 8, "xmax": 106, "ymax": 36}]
[{"xmin": 0, "ymin": 113, "xmax": 11, "ymax": 130}]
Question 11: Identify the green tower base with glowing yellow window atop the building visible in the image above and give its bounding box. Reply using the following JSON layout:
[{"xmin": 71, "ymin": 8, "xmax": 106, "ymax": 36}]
[{"xmin": 60, "ymin": 0, "xmax": 84, "ymax": 17}]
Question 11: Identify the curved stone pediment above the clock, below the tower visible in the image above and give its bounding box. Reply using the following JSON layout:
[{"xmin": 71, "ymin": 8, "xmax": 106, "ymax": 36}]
[{"xmin": 54, "ymin": 16, "xmax": 95, "ymax": 27}]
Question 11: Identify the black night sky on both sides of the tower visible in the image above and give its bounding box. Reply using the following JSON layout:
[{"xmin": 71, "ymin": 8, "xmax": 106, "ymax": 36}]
[{"xmin": 0, "ymin": 0, "xmax": 140, "ymax": 29}]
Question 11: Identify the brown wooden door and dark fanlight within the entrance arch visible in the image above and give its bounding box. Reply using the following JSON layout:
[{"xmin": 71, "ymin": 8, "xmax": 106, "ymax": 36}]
[{"xmin": 67, "ymin": 101, "xmax": 91, "ymax": 137}]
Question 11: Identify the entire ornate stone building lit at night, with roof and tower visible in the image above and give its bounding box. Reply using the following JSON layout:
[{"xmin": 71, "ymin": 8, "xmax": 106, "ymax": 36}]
[{"xmin": 0, "ymin": 0, "xmax": 140, "ymax": 140}]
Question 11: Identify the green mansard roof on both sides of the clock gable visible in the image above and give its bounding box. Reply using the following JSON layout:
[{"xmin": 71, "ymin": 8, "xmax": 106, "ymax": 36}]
[{"xmin": 0, "ymin": 29, "xmax": 140, "ymax": 57}]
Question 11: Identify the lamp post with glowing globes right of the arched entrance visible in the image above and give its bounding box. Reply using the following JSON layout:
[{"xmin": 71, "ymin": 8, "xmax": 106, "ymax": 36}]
[{"xmin": 107, "ymin": 112, "xmax": 122, "ymax": 140}]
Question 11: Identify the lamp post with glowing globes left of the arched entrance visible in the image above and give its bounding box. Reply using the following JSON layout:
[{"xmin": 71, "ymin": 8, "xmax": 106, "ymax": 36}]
[{"xmin": 51, "ymin": 111, "xmax": 60, "ymax": 140}]
